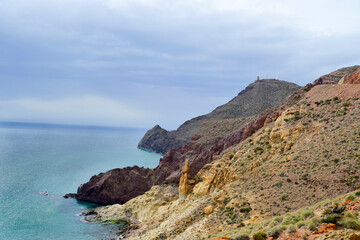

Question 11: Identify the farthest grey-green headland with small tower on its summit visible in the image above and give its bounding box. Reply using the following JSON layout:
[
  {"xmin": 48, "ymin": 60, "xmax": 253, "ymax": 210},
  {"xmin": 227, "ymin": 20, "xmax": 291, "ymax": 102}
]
[{"xmin": 138, "ymin": 79, "xmax": 300, "ymax": 154}]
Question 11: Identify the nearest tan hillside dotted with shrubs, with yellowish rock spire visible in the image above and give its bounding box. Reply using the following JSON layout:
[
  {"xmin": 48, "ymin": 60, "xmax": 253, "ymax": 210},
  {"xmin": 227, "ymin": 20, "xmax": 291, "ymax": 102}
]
[{"xmin": 82, "ymin": 66, "xmax": 360, "ymax": 239}]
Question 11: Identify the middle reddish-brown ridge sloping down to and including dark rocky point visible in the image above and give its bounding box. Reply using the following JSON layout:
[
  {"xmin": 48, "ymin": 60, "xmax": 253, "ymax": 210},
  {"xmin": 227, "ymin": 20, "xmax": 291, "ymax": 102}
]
[{"xmin": 72, "ymin": 80, "xmax": 296, "ymax": 204}]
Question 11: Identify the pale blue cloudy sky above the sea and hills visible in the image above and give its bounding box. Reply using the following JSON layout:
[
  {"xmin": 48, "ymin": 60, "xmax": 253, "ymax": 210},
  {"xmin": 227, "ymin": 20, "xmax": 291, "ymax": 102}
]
[{"xmin": 0, "ymin": 0, "xmax": 360, "ymax": 129}]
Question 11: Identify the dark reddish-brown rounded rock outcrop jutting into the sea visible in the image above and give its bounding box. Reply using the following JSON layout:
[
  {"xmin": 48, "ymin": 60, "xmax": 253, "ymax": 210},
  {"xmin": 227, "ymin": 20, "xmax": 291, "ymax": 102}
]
[{"xmin": 75, "ymin": 166, "xmax": 154, "ymax": 204}]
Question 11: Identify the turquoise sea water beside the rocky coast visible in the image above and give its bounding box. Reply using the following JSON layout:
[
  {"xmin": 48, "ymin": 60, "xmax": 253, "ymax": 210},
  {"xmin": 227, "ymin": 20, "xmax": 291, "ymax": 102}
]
[{"xmin": 0, "ymin": 123, "xmax": 161, "ymax": 240}]
